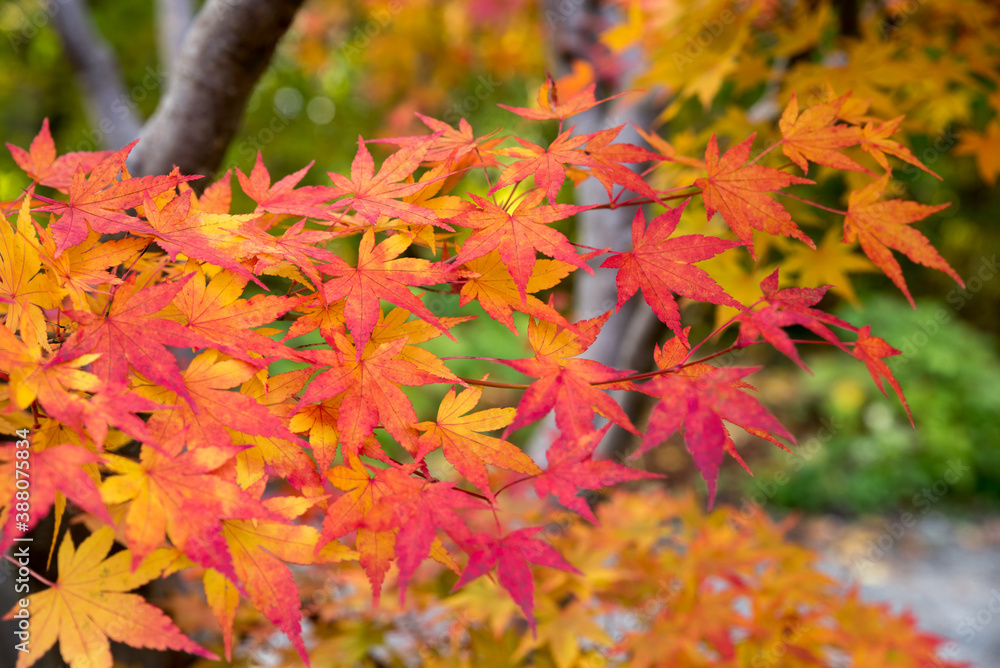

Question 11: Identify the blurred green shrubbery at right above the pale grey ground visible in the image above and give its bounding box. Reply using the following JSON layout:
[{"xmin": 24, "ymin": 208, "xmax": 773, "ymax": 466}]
[{"xmin": 731, "ymin": 294, "xmax": 1000, "ymax": 514}]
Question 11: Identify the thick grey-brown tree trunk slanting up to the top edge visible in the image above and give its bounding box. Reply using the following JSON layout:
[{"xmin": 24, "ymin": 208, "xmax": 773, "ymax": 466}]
[{"xmin": 129, "ymin": 0, "xmax": 304, "ymax": 188}]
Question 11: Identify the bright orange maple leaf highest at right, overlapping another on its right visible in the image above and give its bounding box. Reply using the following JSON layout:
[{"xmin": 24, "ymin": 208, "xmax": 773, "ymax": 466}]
[{"xmin": 778, "ymin": 92, "xmax": 868, "ymax": 174}]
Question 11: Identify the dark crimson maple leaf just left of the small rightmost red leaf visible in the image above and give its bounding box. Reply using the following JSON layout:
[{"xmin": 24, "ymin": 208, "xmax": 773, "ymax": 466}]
[{"xmin": 737, "ymin": 269, "xmax": 856, "ymax": 373}]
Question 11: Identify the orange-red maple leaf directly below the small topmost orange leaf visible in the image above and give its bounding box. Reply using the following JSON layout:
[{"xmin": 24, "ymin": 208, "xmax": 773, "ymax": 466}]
[{"xmin": 489, "ymin": 128, "xmax": 587, "ymax": 204}]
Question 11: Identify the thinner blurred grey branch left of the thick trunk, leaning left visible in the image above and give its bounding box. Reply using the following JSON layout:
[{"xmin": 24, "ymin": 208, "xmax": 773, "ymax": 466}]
[{"xmin": 49, "ymin": 0, "xmax": 141, "ymax": 149}]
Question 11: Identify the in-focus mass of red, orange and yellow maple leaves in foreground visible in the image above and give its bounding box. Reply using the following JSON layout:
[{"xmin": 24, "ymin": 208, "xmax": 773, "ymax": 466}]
[{"xmin": 0, "ymin": 80, "xmax": 961, "ymax": 668}]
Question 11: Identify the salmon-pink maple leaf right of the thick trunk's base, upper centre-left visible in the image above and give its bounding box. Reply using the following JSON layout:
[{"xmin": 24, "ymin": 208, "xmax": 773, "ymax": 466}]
[{"xmin": 327, "ymin": 134, "xmax": 454, "ymax": 231}]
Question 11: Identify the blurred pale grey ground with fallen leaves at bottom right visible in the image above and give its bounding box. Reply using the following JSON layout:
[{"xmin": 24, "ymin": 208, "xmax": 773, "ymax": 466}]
[{"xmin": 792, "ymin": 512, "xmax": 1000, "ymax": 668}]
